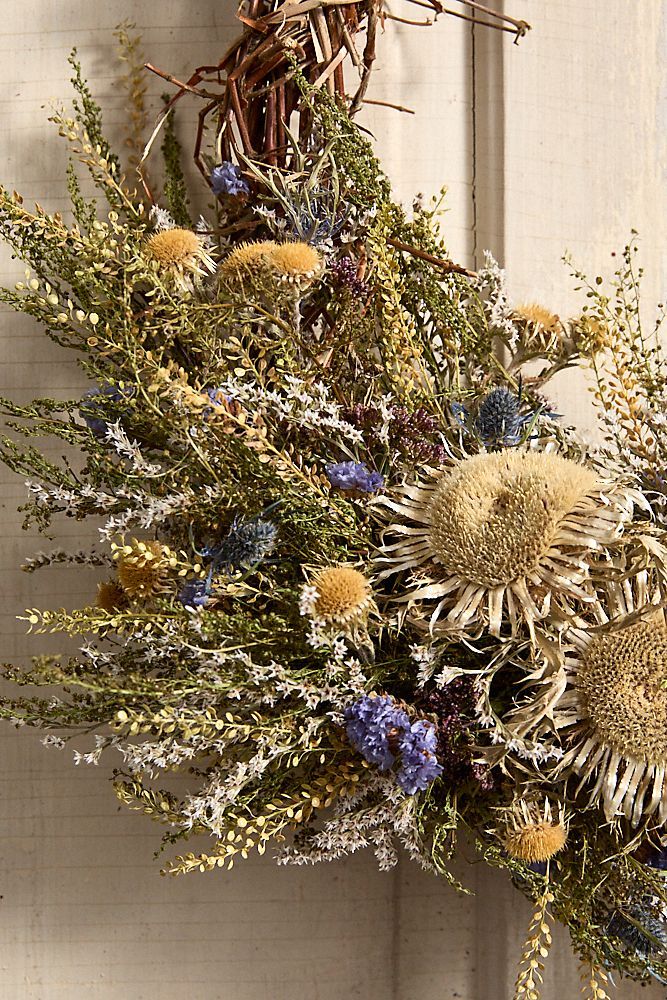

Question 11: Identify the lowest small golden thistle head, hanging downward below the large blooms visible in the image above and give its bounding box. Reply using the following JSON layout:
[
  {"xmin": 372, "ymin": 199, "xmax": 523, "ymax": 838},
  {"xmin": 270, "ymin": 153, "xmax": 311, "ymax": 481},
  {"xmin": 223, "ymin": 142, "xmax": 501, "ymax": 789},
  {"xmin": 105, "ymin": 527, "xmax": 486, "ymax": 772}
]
[{"xmin": 501, "ymin": 799, "xmax": 567, "ymax": 864}]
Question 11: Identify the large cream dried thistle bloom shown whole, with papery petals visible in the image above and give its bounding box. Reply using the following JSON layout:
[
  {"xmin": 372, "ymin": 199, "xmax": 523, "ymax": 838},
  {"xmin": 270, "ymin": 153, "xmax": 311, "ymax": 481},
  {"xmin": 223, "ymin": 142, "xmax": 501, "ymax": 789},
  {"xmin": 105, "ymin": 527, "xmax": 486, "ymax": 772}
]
[{"xmin": 375, "ymin": 450, "xmax": 633, "ymax": 635}]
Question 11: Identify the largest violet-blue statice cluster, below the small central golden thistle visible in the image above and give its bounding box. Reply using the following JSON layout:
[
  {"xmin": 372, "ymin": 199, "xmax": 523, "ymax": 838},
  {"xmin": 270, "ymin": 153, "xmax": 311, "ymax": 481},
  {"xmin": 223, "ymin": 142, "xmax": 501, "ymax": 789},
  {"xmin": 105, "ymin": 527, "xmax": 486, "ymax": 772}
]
[{"xmin": 345, "ymin": 695, "xmax": 442, "ymax": 795}]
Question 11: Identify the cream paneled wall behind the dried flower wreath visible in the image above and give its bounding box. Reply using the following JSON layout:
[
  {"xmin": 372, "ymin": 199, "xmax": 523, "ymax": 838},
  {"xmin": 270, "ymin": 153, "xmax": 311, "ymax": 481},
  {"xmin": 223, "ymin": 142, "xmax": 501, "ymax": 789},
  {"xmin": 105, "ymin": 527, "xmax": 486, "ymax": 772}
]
[{"xmin": 0, "ymin": 0, "xmax": 667, "ymax": 1000}]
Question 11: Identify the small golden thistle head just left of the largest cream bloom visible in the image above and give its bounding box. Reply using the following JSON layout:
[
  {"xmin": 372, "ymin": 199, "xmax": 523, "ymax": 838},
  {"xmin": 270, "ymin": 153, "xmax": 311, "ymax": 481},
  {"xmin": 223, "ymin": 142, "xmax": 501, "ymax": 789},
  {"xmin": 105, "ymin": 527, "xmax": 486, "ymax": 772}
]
[{"xmin": 301, "ymin": 566, "xmax": 374, "ymax": 627}]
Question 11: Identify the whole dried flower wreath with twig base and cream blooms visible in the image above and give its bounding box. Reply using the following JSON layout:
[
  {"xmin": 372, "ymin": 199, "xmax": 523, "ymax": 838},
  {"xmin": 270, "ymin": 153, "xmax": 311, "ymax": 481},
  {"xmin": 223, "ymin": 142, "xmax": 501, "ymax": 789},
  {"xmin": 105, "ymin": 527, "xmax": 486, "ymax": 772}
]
[{"xmin": 0, "ymin": 0, "xmax": 667, "ymax": 1000}]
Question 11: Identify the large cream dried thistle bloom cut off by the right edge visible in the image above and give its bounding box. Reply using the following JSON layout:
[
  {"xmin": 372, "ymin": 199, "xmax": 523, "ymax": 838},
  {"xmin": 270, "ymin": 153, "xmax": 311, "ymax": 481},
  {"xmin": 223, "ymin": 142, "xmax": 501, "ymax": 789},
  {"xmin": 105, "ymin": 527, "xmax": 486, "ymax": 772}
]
[{"xmin": 512, "ymin": 545, "xmax": 667, "ymax": 825}]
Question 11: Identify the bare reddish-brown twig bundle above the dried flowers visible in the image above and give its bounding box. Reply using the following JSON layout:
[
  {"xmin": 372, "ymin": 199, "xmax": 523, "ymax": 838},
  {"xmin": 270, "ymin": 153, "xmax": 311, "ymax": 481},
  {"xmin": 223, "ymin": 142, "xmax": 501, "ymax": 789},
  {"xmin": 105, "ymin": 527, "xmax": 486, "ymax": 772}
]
[{"xmin": 142, "ymin": 0, "xmax": 530, "ymax": 193}]
